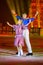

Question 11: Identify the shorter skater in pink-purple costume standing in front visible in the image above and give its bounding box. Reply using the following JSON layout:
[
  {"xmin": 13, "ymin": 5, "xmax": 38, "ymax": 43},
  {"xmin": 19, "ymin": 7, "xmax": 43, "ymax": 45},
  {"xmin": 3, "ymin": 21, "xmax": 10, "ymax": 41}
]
[{"xmin": 7, "ymin": 20, "xmax": 25, "ymax": 56}]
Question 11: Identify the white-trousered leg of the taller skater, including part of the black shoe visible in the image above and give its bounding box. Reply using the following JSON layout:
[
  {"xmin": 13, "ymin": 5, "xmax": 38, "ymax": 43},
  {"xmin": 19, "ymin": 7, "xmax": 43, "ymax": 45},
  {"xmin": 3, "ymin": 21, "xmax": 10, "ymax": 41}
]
[{"xmin": 24, "ymin": 29, "xmax": 32, "ymax": 55}]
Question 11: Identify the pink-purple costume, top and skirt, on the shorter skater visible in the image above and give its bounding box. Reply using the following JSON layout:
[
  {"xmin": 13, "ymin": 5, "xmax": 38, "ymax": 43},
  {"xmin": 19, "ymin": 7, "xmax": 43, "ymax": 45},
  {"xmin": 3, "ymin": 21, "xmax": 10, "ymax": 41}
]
[{"xmin": 13, "ymin": 25, "xmax": 24, "ymax": 46}]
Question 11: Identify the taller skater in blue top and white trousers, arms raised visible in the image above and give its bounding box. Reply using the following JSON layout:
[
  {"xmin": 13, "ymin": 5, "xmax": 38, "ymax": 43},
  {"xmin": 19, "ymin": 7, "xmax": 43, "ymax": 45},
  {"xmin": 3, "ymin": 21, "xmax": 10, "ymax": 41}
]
[{"xmin": 11, "ymin": 10, "xmax": 38, "ymax": 56}]
